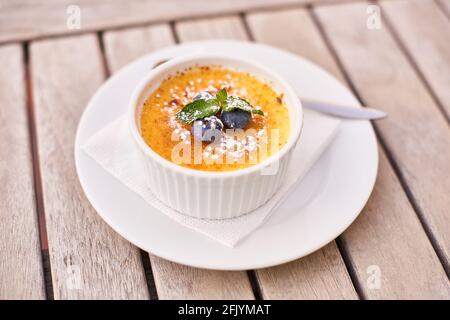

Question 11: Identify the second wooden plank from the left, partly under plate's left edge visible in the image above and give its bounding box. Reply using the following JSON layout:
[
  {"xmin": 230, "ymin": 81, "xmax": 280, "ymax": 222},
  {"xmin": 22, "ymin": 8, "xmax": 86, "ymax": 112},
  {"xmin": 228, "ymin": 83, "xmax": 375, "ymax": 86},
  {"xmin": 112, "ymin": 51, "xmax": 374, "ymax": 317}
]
[{"xmin": 30, "ymin": 35, "xmax": 149, "ymax": 299}]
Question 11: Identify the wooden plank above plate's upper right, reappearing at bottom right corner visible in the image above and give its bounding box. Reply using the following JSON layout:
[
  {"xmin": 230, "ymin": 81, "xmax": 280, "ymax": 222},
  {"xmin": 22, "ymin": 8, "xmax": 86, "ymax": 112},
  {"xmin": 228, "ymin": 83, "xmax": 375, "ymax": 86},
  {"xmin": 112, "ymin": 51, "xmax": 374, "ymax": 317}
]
[{"xmin": 247, "ymin": 6, "xmax": 448, "ymax": 299}]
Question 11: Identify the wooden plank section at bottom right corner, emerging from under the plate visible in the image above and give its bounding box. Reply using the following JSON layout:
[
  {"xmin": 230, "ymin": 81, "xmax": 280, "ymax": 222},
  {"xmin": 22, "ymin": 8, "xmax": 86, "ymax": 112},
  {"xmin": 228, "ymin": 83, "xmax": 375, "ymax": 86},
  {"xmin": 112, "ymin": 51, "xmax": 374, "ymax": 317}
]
[{"xmin": 341, "ymin": 150, "xmax": 450, "ymax": 300}]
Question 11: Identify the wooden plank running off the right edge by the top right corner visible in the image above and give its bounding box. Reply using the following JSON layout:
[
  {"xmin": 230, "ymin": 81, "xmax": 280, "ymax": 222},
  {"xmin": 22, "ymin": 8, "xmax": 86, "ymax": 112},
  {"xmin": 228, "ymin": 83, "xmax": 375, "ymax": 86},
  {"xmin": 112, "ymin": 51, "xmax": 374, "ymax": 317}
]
[{"xmin": 381, "ymin": 0, "xmax": 450, "ymax": 118}]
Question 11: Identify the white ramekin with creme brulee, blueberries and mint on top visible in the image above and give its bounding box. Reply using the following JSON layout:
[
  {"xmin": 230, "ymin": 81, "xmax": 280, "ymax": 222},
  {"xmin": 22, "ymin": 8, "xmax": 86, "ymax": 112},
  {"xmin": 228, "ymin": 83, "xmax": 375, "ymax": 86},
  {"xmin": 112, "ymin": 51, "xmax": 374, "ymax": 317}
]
[{"xmin": 129, "ymin": 54, "xmax": 303, "ymax": 219}]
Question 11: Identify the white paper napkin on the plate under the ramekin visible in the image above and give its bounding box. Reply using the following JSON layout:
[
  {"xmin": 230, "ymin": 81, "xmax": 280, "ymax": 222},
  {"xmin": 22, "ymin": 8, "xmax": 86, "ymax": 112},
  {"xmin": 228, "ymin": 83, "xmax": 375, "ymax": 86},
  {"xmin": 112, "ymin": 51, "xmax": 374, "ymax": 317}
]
[{"xmin": 83, "ymin": 110, "xmax": 340, "ymax": 247}]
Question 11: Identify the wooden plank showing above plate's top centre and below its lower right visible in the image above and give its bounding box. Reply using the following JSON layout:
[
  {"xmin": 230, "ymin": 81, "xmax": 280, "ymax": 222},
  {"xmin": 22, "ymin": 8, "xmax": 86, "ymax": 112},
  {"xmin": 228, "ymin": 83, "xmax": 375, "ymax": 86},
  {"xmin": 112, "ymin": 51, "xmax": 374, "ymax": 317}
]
[{"xmin": 176, "ymin": 17, "xmax": 357, "ymax": 299}]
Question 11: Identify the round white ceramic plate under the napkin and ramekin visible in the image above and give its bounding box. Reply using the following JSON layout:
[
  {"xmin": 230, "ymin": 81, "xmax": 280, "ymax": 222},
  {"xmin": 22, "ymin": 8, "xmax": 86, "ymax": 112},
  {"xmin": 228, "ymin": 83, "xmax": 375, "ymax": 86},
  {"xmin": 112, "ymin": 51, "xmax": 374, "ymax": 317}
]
[{"xmin": 75, "ymin": 40, "xmax": 378, "ymax": 270}]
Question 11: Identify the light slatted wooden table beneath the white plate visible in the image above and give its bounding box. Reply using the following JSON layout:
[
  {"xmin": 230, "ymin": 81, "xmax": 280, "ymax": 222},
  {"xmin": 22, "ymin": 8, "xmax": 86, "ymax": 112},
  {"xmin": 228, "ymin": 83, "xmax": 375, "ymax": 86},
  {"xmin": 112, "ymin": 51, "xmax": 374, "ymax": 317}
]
[{"xmin": 0, "ymin": 0, "xmax": 450, "ymax": 299}]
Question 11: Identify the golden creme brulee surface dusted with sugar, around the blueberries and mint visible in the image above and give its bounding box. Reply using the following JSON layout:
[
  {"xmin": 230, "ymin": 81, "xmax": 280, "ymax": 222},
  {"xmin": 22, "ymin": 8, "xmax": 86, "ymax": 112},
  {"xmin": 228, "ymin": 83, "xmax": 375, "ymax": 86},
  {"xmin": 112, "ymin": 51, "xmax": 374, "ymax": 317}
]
[{"xmin": 140, "ymin": 66, "xmax": 290, "ymax": 171}]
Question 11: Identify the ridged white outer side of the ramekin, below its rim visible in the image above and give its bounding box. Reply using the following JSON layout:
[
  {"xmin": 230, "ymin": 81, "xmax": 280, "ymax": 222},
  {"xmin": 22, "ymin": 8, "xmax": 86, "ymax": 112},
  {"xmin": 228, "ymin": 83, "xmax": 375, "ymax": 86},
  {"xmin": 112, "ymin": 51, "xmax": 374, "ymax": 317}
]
[{"xmin": 140, "ymin": 145, "xmax": 290, "ymax": 220}]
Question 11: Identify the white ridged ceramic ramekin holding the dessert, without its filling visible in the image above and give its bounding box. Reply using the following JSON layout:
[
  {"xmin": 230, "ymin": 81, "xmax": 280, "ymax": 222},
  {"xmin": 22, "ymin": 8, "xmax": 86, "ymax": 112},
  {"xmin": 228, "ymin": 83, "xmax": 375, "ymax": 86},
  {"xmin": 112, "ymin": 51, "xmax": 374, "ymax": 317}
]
[{"xmin": 129, "ymin": 53, "xmax": 303, "ymax": 219}]
